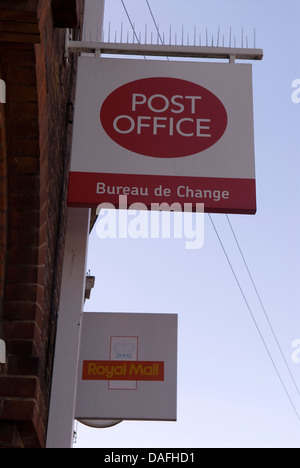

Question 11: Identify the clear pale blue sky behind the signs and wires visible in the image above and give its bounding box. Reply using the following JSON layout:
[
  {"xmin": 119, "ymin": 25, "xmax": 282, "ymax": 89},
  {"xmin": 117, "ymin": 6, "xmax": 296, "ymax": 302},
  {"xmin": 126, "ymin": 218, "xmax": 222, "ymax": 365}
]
[{"xmin": 74, "ymin": 0, "xmax": 300, "ymax": 448}]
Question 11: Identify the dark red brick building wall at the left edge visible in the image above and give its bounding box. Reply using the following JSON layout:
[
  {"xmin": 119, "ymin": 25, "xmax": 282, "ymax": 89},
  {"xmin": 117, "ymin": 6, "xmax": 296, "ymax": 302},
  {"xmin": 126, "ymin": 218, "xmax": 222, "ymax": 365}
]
[{"xmin": 0, "ymin": 0, "xmax": 84, "ymax": 448}]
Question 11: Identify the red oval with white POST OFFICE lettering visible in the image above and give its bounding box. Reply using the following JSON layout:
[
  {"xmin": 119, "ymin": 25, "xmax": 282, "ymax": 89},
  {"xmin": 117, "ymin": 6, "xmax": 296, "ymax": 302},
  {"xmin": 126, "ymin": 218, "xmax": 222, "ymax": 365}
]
[{"xmin": 100, "ymin": 77, "xmax": 228, "ymax": 158}]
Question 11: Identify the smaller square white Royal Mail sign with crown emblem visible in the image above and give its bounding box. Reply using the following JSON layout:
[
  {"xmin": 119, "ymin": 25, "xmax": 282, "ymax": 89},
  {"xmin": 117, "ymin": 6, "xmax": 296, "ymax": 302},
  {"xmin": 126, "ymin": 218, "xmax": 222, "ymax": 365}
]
[{"xmin": 76, "ymin": 313, "xmax": 177, "ymax": 421}]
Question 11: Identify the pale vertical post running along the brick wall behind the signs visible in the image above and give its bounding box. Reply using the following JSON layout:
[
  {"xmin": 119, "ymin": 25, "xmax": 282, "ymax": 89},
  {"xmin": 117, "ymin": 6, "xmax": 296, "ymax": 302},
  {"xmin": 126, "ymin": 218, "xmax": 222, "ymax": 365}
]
[{"xmin": 46, "ymin": 0, "xmax": 105, "ymax": 448}]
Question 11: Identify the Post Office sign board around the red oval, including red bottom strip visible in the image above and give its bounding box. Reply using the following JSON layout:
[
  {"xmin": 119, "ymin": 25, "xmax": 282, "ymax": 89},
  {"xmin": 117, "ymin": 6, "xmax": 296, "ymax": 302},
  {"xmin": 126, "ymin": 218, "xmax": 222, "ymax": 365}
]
[{"xmin": 69, "ymin": 57, "xmax": 256, "ymax": 214}]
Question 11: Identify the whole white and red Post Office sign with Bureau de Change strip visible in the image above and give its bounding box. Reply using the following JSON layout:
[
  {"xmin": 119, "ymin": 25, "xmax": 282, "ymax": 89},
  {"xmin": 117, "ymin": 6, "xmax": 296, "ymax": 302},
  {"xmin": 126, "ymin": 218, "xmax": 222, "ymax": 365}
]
[{"xmin": 69, "ymin": 57, "xmax": 256, "ymax": 214}]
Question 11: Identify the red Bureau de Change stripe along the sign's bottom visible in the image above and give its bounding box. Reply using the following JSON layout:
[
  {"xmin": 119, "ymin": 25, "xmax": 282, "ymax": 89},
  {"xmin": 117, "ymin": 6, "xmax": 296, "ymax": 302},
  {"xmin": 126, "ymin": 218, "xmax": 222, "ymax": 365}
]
[{"xmin": 68, "ymin": 172, "xmax": 256, "ymax": 214}]
